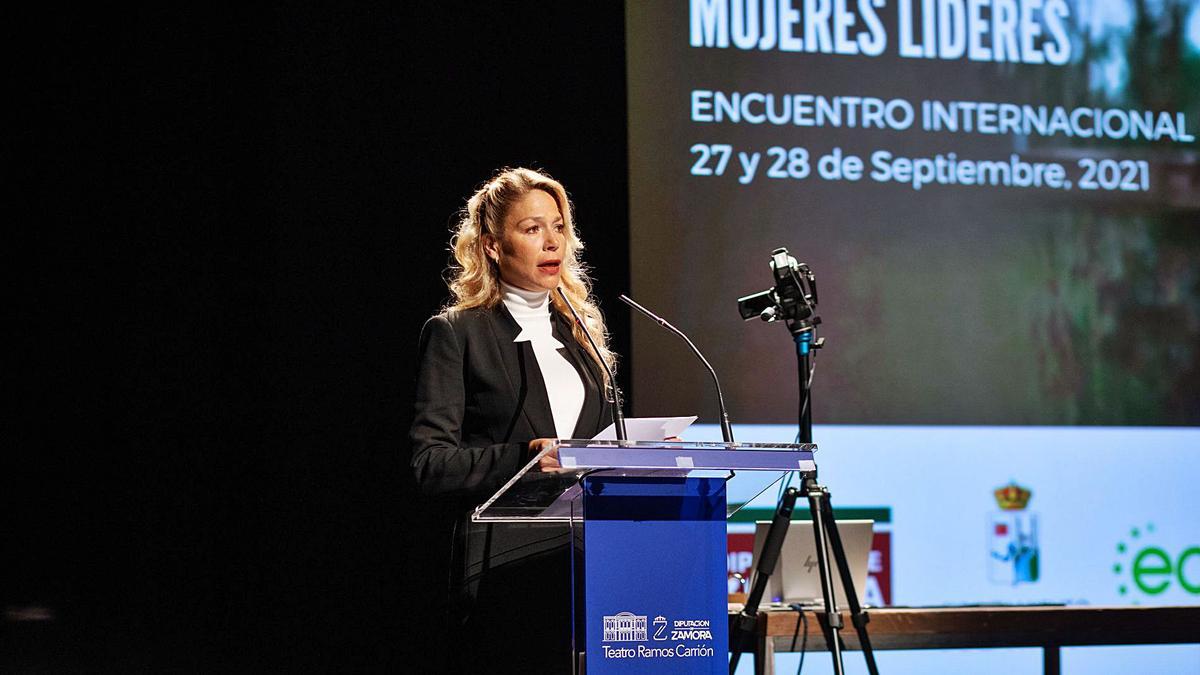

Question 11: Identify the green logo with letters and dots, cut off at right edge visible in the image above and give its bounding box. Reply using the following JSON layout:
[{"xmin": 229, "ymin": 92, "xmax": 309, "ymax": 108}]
[{"xmin": 1112, "ymin": 522, "xmax": 1200, "ymax": 604}]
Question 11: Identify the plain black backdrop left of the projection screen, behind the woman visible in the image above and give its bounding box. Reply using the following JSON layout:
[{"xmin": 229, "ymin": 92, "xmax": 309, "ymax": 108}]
[{"xmin": 7, "ymin": 2, "xmax": 630, "ymax": 673}]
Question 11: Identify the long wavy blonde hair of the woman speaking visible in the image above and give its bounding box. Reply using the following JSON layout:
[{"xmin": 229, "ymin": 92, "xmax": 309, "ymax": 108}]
[{"xmin": 446, "ymin": 163, "xmax": 617, "ymax": 370}]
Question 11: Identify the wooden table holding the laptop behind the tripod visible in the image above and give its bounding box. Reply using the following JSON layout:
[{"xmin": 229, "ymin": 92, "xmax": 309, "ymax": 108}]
[{"xmin": 739, "ymin": 605, "xmax": 1200, "ymax": 675}]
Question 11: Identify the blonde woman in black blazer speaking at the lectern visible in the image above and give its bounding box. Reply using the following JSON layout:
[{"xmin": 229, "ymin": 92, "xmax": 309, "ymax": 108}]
[{"xmin": 409, "ymin": 168, "xmax": 613, "ymax": 673}]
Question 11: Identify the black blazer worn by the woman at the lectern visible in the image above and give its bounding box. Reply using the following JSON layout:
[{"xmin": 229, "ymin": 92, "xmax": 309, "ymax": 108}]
[{"xmin": 409, "ymin": 303, "xmax": 612, "ymax": 503}]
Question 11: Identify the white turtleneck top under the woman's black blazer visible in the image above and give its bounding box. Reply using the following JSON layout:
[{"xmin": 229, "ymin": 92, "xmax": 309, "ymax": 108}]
[{"xmin": 500, "ymin": 281, "xmax": 583, "ymax": 438}]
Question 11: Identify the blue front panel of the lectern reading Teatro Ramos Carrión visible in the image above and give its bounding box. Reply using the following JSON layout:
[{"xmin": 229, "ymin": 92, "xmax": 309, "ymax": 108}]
[{"xmin": 575, "ymin": 476, "xmax": 728, "ymax": 675}]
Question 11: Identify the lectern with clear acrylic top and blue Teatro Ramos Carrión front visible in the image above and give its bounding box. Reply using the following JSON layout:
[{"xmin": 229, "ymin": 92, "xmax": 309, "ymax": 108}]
[{"xmin": 472, "ymin": 441, "xmax": 816, "ymax": 675}]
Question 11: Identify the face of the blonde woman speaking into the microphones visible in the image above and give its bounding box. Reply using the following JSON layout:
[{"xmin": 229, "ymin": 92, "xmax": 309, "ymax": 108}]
[{"xmin": 485, "ymin": 190, "xmax": 566, "ymax": 291}]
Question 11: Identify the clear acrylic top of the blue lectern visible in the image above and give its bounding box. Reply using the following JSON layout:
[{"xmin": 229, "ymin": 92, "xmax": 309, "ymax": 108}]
[{"xmin": 472, "ymin": 440, "xmax": 816, "ymax": 522}]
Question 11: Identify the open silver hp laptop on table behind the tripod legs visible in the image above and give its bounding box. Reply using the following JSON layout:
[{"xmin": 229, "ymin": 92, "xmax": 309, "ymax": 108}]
[{"xmin": 750, "ymin": 520, "xmax": 875, "ymax": 609}]
